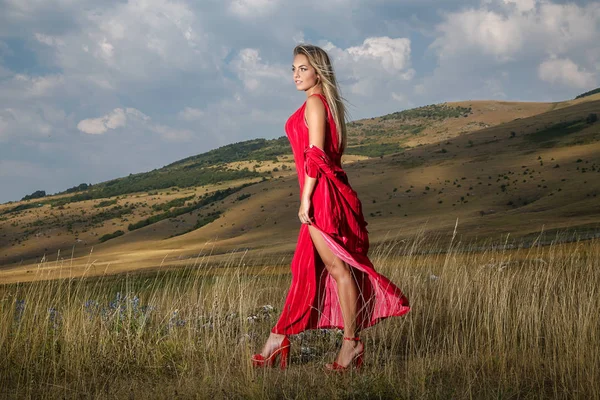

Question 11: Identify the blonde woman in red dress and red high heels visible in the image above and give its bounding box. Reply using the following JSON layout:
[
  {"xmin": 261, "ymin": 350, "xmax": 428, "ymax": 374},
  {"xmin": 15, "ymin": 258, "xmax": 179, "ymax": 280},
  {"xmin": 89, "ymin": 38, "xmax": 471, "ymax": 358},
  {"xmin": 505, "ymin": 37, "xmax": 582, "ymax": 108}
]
[{"xmin": 252, "ymin": 45, "xmax": 410, "ymax": 371}]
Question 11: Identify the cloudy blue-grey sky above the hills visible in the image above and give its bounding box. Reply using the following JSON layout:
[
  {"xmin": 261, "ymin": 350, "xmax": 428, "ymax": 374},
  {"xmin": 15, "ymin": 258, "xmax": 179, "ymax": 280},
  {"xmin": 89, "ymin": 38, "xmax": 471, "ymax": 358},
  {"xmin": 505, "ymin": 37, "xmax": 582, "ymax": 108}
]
[{"xmin": 0, "ymin": 0, "xmax": 600, "ymax": 203}]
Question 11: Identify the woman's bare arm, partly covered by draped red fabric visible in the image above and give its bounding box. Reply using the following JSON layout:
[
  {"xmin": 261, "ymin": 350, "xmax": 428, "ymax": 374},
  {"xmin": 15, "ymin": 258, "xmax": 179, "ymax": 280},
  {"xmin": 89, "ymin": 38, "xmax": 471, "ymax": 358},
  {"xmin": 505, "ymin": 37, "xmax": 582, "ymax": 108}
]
[{"xmin": 298, "ymin": 96, "xmax": 327, "ymax": 224}]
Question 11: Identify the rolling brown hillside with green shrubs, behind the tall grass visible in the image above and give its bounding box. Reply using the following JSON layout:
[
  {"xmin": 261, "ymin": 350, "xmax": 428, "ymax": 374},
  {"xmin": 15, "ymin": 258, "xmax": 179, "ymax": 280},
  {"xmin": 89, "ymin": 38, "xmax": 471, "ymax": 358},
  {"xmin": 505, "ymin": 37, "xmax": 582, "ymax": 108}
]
[{"xmin": 0, "ymin": 93, "xmax": 600, "ymax": 281}]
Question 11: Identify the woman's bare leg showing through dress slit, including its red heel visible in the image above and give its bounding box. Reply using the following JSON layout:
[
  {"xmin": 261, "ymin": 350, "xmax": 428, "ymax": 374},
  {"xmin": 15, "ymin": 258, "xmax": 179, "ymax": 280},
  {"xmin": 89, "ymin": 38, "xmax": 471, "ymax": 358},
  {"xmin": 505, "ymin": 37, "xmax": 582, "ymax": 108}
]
[{"xmin": 308, "ymin": 225, "xmax": 362, "ymax": 366}]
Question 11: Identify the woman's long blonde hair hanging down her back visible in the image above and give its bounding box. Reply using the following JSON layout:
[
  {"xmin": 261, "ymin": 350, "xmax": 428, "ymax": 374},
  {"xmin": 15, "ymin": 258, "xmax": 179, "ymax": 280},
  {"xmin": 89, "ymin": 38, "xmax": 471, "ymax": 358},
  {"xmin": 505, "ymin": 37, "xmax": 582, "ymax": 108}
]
[{"xmin": 294, "ymin": 44, "xmax": 348, "ymax": 153}]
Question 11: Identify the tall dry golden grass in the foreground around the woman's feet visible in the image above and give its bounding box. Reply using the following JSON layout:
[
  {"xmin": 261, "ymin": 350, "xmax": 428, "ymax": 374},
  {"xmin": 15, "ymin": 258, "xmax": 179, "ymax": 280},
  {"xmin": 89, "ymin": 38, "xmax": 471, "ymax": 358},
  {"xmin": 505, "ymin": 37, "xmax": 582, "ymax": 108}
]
[{"xmin": 0, "ymin": 231, "xmax": 600, "ymax": 399}]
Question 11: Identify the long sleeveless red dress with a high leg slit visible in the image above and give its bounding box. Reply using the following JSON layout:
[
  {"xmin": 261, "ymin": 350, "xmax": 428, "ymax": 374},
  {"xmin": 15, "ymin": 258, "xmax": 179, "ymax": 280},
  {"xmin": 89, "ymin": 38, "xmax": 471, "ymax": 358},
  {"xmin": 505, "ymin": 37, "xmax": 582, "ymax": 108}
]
[{"xmin": 271, "ymin": 94, "xmax": 410, "ymax": 335}]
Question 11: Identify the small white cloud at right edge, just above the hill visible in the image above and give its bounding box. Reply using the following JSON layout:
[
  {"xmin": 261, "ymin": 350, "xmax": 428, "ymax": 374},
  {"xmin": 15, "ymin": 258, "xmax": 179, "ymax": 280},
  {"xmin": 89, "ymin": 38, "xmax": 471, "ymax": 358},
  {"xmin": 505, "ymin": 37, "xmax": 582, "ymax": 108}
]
[{"xmin": 538, "ymin": 58, "xmax": 596, "ymax": 89}]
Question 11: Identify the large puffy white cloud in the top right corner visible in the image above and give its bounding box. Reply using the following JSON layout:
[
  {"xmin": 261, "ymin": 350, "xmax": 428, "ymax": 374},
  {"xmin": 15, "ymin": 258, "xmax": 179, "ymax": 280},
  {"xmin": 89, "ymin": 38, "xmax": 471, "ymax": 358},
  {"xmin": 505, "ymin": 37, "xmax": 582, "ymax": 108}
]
[{"xmin": 430, "ymin": 0, "xmax": 600, "ymax": 62}]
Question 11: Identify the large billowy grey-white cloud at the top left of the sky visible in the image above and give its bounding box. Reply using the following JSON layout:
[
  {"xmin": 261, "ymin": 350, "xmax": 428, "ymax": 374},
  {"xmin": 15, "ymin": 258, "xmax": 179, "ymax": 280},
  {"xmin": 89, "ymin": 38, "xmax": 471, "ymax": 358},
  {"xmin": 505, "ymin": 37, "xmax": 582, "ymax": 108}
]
[{"xmin": 28, "ymin": 0, "xmax": 216, "ymax": 90}]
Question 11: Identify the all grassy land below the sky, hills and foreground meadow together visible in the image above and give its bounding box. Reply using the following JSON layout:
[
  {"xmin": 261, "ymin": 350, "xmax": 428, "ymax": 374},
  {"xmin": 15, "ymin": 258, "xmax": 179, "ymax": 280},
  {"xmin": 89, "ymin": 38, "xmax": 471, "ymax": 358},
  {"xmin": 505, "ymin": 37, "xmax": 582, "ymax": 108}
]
[{"xmin": 0, "ymin": 93, "xmax": 600, "ymax": 399}]
